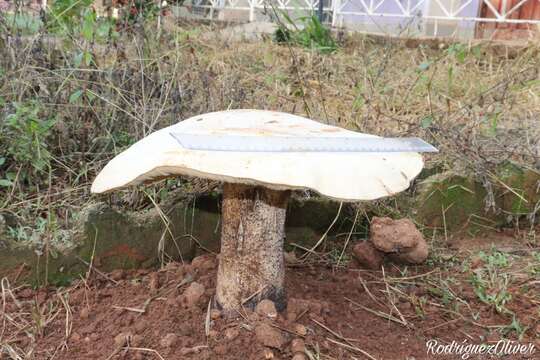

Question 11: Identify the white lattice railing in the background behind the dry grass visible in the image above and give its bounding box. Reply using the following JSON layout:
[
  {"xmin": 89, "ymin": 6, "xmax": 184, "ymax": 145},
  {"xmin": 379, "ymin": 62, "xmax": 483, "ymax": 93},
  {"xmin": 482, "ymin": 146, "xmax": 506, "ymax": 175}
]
[{"xmin": 192, "ymin": 0, "xmax": 540, "ymax": 37}]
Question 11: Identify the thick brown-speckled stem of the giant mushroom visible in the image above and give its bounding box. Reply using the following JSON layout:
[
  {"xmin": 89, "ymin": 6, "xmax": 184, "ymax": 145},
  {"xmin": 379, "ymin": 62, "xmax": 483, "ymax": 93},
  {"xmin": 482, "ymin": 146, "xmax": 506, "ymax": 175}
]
[{"xmin": 216, "ymin": 183, "xmax": 290, "ymax": 316}]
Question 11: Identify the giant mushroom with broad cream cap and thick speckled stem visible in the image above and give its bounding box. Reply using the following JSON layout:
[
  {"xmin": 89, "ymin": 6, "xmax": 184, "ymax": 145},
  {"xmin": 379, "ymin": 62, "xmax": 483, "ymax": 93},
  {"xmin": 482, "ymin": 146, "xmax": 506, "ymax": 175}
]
[{"xmin": 91, "ymin": 110, "xmax": 430, "ymax": 315}]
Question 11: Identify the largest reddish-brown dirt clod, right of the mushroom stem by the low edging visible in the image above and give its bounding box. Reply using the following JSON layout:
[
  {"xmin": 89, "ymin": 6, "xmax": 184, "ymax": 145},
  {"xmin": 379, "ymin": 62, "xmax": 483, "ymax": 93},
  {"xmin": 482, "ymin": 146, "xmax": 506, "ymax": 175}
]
[{"xmin": 370, "ymin": 217, "xmax": 428, "ymax": 264}]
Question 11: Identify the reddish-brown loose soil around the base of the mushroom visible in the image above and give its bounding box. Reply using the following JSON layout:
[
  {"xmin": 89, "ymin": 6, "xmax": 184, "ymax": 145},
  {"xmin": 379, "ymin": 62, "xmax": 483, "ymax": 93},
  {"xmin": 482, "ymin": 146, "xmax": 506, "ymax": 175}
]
[{"xmin": 0, "ymin": 248, "xmax": 540, "ymax": 359}]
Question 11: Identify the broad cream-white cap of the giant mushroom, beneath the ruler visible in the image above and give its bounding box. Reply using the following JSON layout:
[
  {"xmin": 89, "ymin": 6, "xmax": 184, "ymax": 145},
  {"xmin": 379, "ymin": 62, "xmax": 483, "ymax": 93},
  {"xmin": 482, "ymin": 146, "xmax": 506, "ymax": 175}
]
[{"xmin": 91, "ymin": 110, "xmax": 423, "ymax": 201}]
